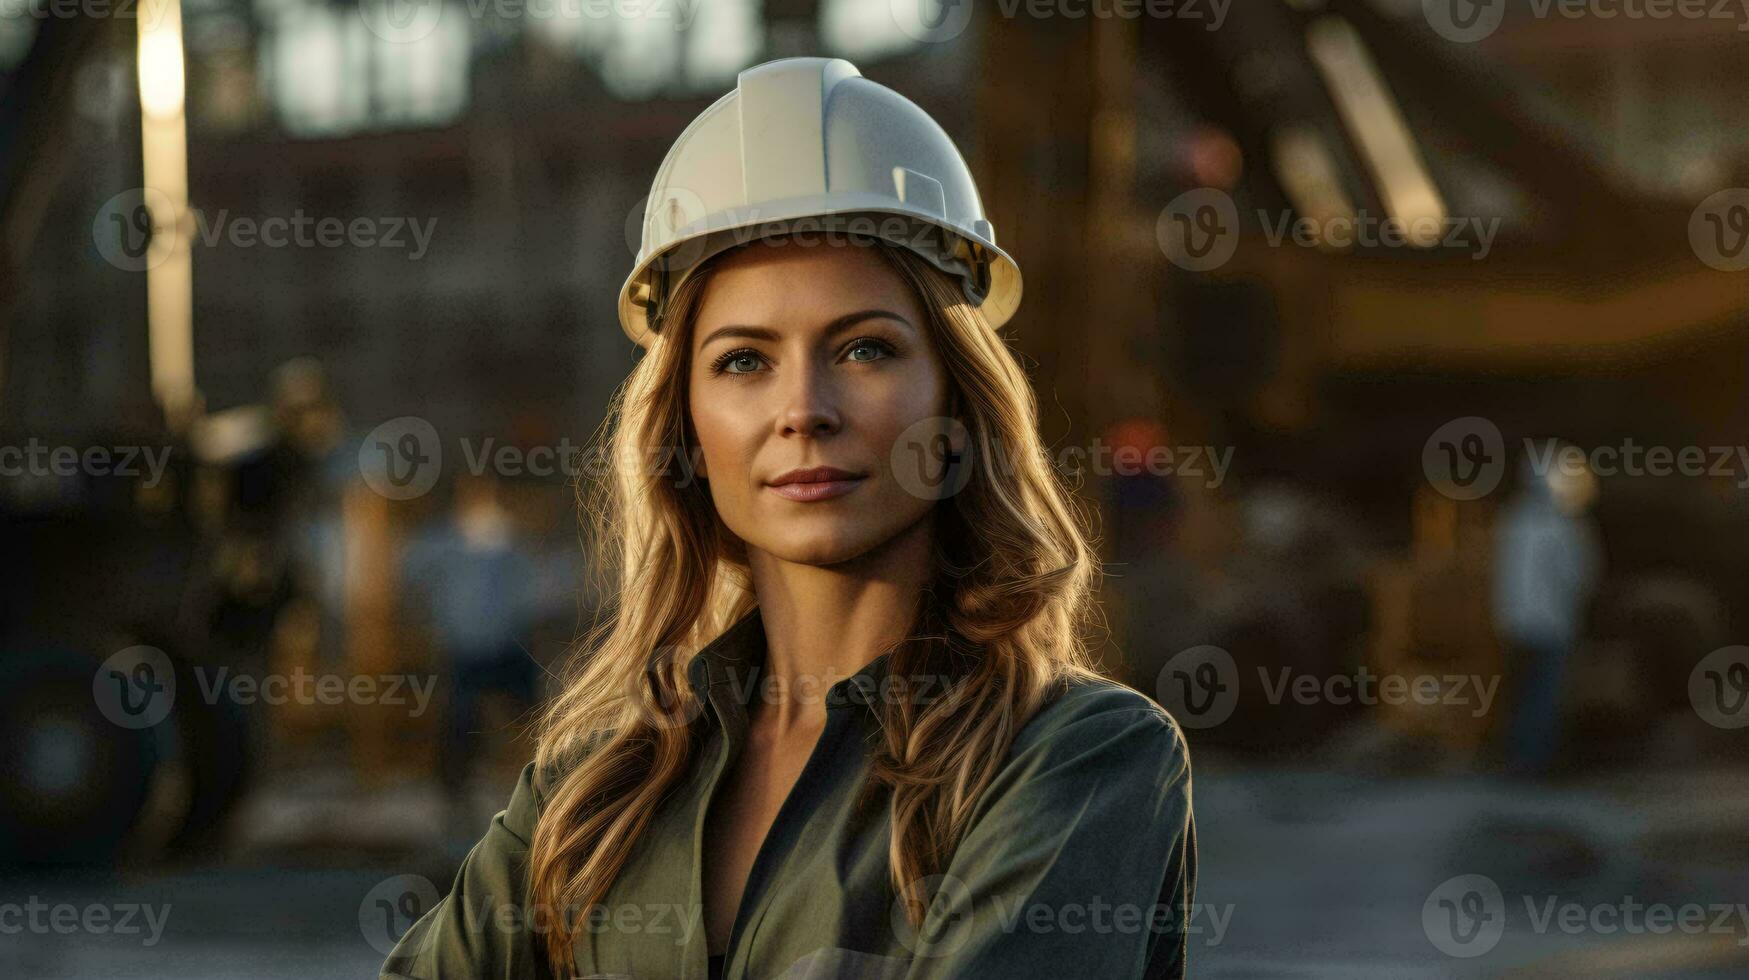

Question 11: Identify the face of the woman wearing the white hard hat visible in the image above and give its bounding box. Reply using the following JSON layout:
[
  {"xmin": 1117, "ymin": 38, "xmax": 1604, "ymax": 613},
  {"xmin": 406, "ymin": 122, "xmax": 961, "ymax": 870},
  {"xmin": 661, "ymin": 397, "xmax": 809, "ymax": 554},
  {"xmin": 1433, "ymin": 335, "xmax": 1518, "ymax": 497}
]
[{"xmin": 687, "ymin": 242, "xmax": 948, "ymax": 565}]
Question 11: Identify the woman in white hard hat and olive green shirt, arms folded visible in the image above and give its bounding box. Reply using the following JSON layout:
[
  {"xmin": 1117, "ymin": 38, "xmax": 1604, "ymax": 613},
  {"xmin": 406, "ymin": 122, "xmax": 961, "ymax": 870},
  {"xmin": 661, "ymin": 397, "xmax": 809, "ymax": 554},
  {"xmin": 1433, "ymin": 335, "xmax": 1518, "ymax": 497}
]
[{"xmin": 385, "ymin": 58, "xmax": 1196, "ymax": 980}]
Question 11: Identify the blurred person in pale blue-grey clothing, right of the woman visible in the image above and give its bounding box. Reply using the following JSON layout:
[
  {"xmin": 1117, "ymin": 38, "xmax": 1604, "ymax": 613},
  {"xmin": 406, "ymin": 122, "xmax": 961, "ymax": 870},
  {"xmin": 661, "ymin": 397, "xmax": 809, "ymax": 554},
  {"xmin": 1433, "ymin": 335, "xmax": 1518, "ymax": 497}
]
[{"xmin": 1494, "ymin": 441, "xmax": 1604, "ymax": 775}]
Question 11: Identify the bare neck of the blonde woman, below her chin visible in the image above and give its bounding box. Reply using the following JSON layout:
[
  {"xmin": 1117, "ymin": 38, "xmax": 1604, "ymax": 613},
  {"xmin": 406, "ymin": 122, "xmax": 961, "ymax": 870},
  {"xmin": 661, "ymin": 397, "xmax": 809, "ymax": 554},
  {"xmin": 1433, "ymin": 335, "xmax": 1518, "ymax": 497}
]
[{"xmin": 749, "ymin": 518, "xmax": 934, "ymax": 732}]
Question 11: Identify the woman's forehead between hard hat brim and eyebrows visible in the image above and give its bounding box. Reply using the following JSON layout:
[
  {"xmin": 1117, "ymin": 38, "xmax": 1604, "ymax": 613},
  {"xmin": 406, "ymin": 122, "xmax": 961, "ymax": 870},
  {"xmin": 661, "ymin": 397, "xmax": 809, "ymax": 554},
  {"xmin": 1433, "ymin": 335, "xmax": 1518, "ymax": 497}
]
[{"xmin": 694, "ymin": 240, "xmax": 922, "ymax": 338}]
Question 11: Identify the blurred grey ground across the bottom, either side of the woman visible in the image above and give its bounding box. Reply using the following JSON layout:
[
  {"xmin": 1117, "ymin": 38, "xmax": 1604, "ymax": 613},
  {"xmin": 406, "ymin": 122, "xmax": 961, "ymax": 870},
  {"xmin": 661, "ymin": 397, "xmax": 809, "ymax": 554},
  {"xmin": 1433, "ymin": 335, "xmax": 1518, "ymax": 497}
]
[{"xmin": 0, "ymin": 758, "xmax": 1749, "ymax": 980}]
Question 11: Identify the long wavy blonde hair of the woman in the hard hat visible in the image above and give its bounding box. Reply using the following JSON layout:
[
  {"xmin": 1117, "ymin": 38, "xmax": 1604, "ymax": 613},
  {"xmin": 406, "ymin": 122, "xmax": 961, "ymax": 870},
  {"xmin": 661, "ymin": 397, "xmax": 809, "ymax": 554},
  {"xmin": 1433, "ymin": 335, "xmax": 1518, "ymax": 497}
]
[{"xmin": 530, "ymin": 243, "xmax": 1100, "ymax": 977}]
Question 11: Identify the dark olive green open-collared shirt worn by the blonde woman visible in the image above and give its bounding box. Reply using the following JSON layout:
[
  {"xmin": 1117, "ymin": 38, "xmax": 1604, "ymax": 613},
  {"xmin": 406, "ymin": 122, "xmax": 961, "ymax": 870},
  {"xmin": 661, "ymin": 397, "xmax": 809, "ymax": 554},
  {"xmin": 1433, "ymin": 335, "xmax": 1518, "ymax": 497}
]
[{"xmin": 383, "ymin": 609, "xmax": 1196, "ymax": 980}]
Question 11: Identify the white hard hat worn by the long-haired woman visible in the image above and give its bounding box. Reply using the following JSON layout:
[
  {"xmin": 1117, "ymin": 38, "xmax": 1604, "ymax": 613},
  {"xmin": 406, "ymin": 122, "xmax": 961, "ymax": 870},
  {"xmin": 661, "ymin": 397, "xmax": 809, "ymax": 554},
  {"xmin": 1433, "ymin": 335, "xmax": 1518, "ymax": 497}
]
[{"xmin": 619, "ymin": 58, "xmax": 1020, "ymax": 347}]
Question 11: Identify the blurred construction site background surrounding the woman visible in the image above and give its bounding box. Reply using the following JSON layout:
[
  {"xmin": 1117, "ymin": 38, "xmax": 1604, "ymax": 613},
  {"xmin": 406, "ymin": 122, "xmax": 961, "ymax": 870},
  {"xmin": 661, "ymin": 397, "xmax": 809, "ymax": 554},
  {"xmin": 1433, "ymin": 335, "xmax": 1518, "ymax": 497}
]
[{"xmin": 0, "ymin": 0, "xmax": 1749, "ymax": 978}]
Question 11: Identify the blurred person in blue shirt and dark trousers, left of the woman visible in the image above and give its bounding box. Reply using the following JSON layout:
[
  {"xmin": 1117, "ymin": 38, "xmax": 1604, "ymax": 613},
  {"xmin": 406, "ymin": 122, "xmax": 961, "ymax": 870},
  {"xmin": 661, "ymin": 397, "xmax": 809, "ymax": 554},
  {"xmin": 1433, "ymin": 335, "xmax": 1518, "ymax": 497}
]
[{"xmin": 404, "ymin": 474, "xmax": 539, "ymax": 837}]
